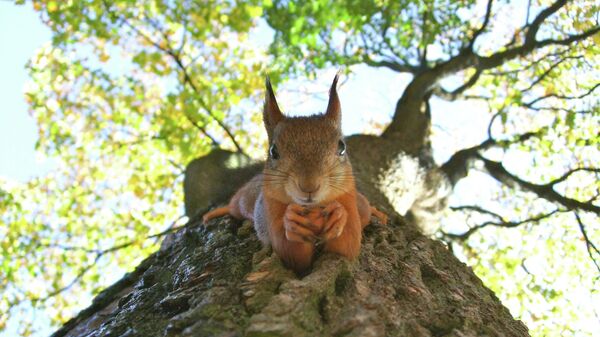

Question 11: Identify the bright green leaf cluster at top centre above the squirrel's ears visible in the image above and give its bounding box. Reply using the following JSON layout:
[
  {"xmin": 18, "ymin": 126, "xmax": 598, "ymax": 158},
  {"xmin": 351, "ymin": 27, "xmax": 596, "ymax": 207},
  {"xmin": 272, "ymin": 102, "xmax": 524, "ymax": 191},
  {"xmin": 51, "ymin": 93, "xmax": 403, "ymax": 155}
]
[{"xmin": 267, "ymin": 0, "xmax": 476, "ymax": 72}]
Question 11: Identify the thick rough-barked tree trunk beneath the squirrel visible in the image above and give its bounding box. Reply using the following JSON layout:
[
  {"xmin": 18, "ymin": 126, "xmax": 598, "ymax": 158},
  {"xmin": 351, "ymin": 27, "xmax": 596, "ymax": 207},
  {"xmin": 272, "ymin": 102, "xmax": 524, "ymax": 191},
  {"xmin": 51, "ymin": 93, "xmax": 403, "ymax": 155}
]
[{"xmin": 53, "ymin": 136, "xmax": 528, "ymax": 337}]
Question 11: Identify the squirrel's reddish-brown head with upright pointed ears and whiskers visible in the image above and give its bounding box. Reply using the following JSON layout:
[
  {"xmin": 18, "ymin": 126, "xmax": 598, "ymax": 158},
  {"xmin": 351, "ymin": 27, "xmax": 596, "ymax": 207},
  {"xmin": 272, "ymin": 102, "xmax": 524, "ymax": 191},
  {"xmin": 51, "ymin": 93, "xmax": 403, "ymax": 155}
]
[{"xmin": 263, "ymin": 75, "xmax": 354, "ymax": 206}]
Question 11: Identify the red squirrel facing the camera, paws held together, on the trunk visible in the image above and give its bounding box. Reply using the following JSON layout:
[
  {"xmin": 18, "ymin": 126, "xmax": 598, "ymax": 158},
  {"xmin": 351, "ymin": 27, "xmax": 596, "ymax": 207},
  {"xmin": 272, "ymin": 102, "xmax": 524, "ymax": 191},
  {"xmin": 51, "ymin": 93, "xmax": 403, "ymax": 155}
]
[{"xmin": 203, "ymin": 75, "xmax": 387, "ymax": 274}]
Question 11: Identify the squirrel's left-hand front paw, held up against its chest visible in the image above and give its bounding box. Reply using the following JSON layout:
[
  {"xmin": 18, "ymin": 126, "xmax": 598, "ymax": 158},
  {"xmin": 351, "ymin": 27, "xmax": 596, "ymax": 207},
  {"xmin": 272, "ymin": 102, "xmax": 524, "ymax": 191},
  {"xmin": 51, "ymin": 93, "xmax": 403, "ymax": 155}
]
[{"xmin": 283, "ymin": 204, "xmax": 321, "ymax": 244}]
